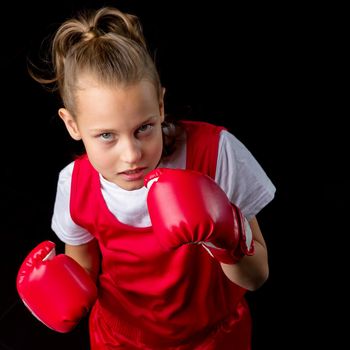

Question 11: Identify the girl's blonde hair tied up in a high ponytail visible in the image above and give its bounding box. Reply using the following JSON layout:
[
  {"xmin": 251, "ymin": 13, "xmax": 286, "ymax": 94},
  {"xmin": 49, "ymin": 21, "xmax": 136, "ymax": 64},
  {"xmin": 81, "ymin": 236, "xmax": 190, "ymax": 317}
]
[{"xmin": 29, "ymin": 7, "xmax": 162, "ymax": 115}]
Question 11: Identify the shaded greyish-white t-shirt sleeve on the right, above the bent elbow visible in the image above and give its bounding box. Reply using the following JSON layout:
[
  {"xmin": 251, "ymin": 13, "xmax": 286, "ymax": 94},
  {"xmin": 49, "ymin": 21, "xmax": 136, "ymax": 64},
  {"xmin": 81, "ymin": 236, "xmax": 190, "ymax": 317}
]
[{"xmin": 215, "ymin": 130, "xmax": 276, "ymax": 220}]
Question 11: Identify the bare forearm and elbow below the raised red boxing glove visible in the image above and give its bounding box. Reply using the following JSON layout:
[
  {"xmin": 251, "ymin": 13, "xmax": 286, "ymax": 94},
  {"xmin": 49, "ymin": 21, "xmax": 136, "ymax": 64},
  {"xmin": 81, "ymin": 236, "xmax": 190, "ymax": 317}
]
[{"xmin": 221, "ymin": 217, "xmax": 269, "ymax": 291}]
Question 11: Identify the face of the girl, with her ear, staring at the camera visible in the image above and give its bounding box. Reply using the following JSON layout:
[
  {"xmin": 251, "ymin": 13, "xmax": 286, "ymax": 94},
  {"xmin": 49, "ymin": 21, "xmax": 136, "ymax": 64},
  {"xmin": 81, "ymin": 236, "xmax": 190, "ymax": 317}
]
[{"xmin": 59, "ymin": 79, "xmax": 164, "ymax": 190}]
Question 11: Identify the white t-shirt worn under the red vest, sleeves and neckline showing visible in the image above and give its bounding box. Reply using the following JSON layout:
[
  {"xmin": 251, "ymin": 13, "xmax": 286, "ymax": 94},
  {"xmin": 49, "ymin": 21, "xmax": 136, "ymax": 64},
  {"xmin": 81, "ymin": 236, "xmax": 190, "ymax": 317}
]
[{"xmin": 52, "ymin": 130, "xmax": 276, "ymax": 245}]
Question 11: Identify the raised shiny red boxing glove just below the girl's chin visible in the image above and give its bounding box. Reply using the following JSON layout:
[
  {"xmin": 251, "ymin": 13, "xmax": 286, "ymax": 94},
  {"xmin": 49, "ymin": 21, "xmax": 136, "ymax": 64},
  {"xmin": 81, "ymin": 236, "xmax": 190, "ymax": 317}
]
[{"xmin": 145, "ymin": 168, "xmax": 254, "ymax": 264}]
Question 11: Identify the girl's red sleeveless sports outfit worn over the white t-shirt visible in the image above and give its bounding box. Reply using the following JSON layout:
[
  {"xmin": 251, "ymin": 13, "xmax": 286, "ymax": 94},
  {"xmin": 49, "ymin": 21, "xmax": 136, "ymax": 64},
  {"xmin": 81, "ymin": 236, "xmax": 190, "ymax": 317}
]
[{"xmin": 70, "ymin": 122, "xmax": 251, "ymax": 350}]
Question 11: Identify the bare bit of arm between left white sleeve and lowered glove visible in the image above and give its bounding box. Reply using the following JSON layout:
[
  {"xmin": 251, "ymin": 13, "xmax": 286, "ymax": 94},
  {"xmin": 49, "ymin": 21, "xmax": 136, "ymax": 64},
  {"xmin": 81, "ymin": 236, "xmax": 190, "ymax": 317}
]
[{"xmin": 65, "ymin": 239, "xmax": 101, "ymax": 282}]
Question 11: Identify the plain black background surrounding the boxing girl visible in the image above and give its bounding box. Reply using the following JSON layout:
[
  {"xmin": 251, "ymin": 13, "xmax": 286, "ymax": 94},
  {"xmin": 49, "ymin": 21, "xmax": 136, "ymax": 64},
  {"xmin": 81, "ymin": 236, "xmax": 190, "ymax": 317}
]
[{"xmin": 0, "ymin": 1, "xmax": 349, "ymax": 350}]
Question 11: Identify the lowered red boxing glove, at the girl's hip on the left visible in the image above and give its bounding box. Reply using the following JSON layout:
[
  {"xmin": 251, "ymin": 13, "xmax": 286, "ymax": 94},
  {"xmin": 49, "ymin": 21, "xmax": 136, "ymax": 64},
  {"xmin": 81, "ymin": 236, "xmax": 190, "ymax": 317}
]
[{"xmin": 17, "ymin": 241, "xmax": 97, "ymax": 333}]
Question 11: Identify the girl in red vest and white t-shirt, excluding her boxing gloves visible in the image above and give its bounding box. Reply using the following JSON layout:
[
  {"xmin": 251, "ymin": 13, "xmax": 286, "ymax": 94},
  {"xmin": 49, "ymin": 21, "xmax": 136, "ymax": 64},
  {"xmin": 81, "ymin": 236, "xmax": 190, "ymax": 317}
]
[{"xmin": 24, "ymin": 7, "xmax": 275, "ymax": 350}]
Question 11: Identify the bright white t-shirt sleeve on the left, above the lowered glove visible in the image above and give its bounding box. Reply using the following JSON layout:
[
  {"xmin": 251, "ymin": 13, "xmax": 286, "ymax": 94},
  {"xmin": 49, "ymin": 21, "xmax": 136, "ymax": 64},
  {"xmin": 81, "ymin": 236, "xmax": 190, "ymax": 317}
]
[{"xmin": 51, "ymin": 162, "xmax": 94, "ymax": 245}]
